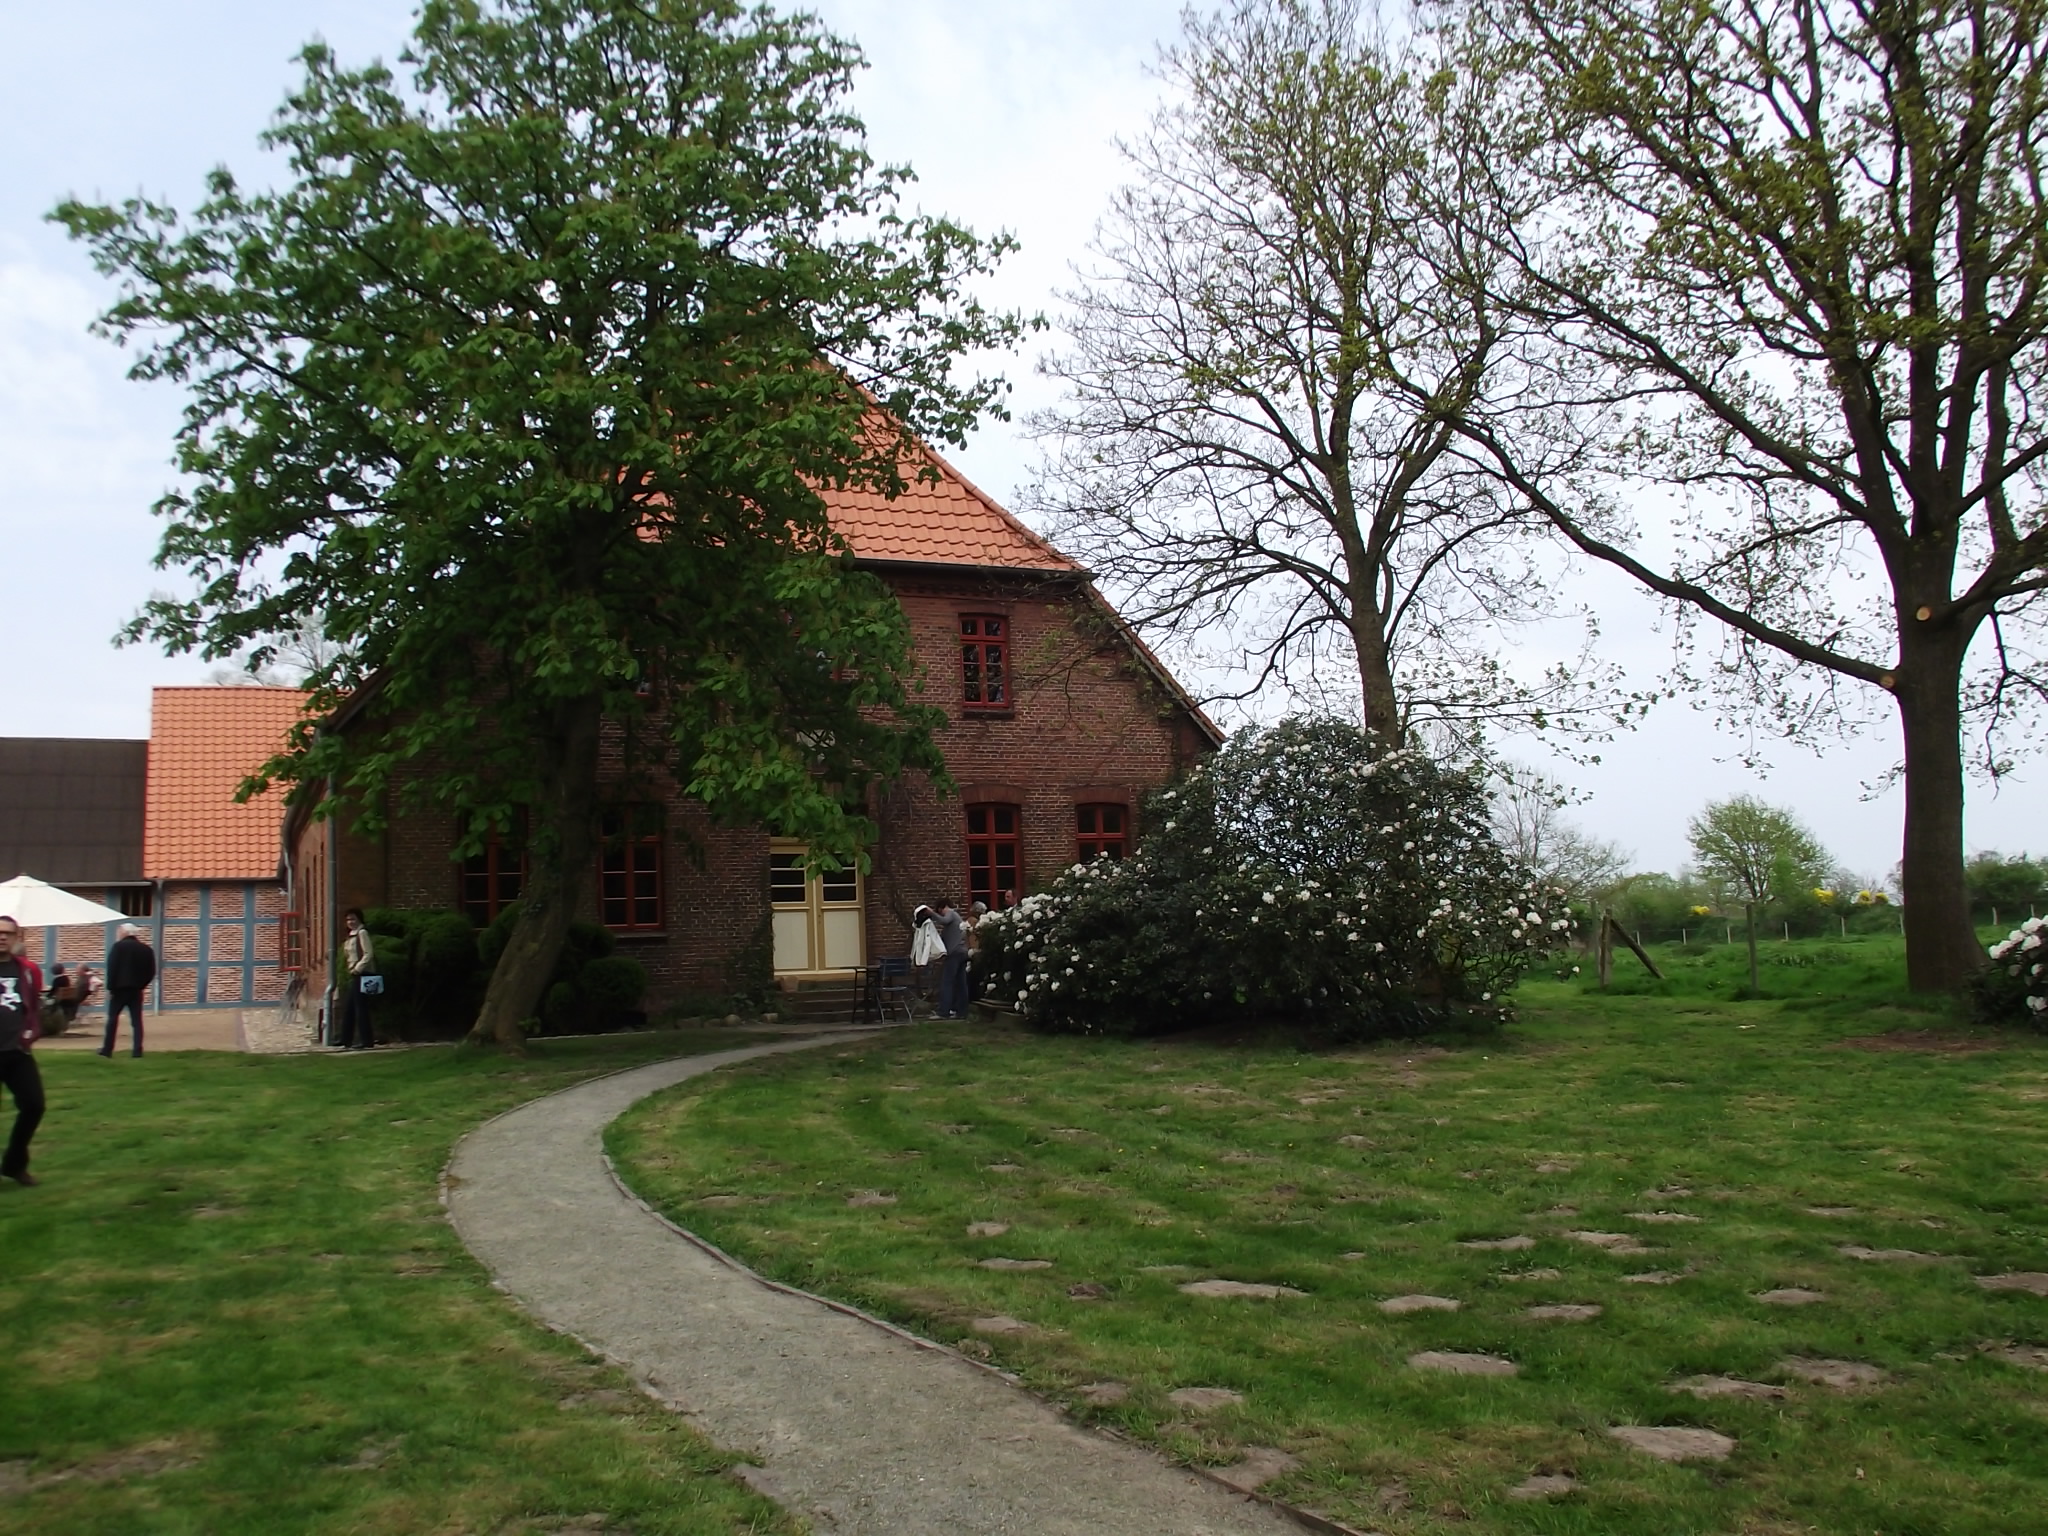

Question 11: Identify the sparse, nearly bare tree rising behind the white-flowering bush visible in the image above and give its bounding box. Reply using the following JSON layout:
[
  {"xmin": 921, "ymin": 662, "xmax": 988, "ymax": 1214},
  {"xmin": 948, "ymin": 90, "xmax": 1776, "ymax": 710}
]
[{"xmin": 1034, "ymin": 0, "xmax": 1647, "ymax": 741}]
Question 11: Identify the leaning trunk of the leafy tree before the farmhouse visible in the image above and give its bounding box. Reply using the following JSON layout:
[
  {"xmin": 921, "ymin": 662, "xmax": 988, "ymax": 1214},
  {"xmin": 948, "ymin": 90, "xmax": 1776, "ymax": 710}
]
[{"xmin": 469, "ymin": 696, "xmax": 602, "ymax": 1055}]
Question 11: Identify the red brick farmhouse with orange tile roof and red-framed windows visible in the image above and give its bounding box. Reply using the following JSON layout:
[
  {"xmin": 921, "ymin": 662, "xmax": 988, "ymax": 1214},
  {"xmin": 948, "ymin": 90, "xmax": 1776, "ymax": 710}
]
[{"xmin": 285, "ymin": 442, "xmax": 1221, "ymax": 1024}]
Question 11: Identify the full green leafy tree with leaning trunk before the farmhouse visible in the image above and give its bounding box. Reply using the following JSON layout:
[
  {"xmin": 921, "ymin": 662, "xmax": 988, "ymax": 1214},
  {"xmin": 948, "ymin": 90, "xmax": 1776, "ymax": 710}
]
[{"xmin": 53, "ymin": 0, "xmax": 1018, "ymax": 1049}]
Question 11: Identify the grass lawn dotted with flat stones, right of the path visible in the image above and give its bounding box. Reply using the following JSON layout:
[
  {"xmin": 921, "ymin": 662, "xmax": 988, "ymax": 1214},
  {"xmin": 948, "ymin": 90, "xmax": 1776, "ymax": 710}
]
[{"xmin": 612, "ymin": 940, "xmax": 2048, "ymax": 1536}]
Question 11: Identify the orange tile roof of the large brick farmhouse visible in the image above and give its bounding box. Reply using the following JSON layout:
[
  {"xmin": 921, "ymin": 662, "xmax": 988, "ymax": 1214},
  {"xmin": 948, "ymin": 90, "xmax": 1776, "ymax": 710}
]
[{"xmin": 825, "ymin": 444, "xmax": 1081, "ymax": 573}]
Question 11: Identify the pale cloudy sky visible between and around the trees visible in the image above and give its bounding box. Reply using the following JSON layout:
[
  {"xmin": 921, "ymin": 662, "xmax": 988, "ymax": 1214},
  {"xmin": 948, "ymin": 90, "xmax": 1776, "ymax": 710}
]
[{"xmin": 0, "ymin": 0, "xmax": 2048, "ymax": 874}]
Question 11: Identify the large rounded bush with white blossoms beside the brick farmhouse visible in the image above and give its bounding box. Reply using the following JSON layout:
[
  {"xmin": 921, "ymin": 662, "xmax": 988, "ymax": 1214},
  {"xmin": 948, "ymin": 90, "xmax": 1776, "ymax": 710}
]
[{"xmin": 975, "ymin": 719, "xmax": 1571, "ymax": 1036}]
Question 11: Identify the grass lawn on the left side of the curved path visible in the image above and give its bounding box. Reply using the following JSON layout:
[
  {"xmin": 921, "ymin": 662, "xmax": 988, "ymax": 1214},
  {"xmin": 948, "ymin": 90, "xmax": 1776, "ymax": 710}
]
[{"xmin": 0, "ymin": 1034, "xmax": 793, "ymax": 1536}]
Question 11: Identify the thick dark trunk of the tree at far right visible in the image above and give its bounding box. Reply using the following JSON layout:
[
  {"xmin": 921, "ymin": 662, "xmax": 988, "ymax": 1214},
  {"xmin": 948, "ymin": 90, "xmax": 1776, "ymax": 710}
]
[{"xmin": 1894, "ymin": 631, "xmax": 1985, "ymax": 991}]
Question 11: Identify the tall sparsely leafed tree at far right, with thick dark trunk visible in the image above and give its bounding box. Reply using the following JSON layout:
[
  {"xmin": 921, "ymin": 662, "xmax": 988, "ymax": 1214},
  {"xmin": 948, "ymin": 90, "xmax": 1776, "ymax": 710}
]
[{"xmin": 1446, "ymin": 0, "xmax": 2048, "ymax": 991}]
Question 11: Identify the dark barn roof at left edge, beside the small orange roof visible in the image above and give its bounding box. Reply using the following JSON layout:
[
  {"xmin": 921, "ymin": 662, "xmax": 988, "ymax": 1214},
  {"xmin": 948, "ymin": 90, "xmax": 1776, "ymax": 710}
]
[{"xmin": 0, "ymin": 735, "xmax": 150, "ymax": 885}]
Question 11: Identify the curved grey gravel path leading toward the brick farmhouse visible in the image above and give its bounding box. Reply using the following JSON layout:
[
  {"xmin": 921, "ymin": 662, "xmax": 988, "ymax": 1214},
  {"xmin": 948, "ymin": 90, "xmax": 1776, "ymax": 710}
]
[{"xmin": 446, "ymin": 1036, "xmax": 1300, "ymax": 1536}]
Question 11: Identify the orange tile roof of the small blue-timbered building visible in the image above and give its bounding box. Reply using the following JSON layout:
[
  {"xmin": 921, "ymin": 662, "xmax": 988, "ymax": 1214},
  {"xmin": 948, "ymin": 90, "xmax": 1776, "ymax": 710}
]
[{"xmin": 141, "ymin": 688, "xmax": 305, "ymax": 881}]
